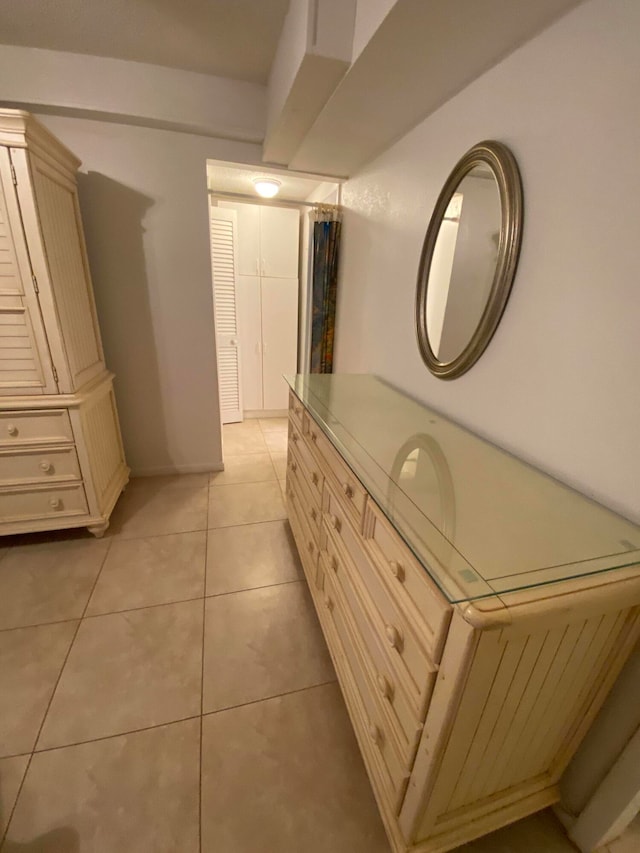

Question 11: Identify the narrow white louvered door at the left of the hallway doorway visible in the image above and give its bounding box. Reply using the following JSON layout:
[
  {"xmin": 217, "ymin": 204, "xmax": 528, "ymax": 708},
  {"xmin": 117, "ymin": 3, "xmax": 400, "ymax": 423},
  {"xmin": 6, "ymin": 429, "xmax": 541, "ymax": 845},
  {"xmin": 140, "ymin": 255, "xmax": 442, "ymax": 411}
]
[{"xmin": 211, "ymin": 207, "xmax": 243, "ymax": 424}]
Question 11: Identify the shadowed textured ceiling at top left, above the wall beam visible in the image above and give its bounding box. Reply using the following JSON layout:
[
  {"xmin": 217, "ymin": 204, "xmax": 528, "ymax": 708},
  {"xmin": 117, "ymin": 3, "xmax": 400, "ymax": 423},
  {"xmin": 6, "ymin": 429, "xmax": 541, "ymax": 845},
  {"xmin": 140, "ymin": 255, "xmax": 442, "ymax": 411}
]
[{"xmin": 0, "ymin": 0, "xmax": 289, "ymax": 83}]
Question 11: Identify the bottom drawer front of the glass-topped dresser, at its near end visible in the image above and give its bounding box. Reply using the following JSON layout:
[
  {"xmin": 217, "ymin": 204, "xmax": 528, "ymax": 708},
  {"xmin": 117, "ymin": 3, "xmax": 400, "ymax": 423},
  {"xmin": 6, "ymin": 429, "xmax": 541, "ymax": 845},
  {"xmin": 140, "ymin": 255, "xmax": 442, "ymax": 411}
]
[{"xmin": 323, "ymin": 569, "xmax": 409, "ymax": 810}]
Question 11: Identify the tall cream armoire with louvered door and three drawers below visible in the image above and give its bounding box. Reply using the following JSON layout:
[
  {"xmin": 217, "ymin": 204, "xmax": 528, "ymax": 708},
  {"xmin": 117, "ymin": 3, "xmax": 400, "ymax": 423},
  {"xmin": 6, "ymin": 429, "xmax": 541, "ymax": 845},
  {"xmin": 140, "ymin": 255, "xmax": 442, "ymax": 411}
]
[{"xmin": 0, "ymin": 110, "xmax": 129, "ymax": 536}]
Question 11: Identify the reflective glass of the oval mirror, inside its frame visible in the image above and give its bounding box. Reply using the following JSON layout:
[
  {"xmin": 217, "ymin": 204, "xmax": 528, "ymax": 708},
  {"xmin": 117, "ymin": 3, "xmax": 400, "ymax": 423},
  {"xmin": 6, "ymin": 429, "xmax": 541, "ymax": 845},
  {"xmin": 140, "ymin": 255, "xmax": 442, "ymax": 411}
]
[{"xmin": 427, "ymin": 164, "xmax": 502, "ymax": 362}]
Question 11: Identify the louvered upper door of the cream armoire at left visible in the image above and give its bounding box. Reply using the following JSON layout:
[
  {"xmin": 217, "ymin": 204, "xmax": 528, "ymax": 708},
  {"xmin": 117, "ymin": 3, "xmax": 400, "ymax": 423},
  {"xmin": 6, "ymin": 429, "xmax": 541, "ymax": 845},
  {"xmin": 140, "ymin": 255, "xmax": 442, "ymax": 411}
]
[{"xmin": 0, "ymin": 147, "xmax": 58, "ymax": 395}]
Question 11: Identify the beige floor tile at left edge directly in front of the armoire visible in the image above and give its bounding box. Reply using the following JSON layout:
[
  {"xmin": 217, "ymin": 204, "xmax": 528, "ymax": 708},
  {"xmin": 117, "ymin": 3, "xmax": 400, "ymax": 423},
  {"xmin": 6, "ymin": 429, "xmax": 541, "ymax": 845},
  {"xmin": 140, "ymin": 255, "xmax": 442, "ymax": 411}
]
[{"xmin": 0, "ymin": 539, "xmax": 109, "ymax": 628}]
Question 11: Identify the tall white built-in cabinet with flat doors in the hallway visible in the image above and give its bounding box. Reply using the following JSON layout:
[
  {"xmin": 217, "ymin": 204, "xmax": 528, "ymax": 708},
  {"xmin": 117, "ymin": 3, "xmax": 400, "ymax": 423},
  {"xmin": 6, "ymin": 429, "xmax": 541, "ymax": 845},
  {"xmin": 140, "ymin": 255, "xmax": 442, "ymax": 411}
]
[{"xmin": 220, "ymin": 202, "xmax": 300, "ymax": 412}]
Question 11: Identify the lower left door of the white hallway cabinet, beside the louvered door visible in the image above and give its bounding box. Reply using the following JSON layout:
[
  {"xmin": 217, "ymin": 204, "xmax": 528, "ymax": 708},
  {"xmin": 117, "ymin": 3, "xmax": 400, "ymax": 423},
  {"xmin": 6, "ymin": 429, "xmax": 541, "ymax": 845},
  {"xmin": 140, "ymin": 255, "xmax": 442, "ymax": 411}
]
[{"xmin": 236, "ymin": 275, "xmax": 263, "ymax": 412}]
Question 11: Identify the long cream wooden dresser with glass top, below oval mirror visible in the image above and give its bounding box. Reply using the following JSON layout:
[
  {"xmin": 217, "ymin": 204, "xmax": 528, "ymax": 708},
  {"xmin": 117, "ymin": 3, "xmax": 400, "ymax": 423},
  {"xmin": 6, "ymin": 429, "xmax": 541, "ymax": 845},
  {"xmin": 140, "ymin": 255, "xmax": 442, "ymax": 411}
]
[{"xmin": 287, "ymin": 375, "xmax": 640, "ymax": 853}]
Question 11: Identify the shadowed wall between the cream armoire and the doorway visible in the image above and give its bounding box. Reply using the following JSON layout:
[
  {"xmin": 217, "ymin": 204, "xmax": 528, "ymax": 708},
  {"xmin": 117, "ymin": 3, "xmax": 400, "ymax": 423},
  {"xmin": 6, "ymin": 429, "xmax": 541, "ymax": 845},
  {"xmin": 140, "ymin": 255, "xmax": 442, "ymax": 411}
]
[{"xmin": 28, "ymin": 115, "xmax": 260, "ymax": 474}]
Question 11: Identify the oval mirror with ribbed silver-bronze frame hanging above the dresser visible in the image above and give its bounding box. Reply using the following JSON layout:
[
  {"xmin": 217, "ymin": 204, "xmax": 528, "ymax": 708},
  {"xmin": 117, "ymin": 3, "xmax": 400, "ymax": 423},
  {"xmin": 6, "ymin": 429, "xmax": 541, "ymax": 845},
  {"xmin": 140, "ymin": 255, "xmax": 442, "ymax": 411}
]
[{"xmin": 416, "ymin": 141, "xmax": 522, "ymax": 379}]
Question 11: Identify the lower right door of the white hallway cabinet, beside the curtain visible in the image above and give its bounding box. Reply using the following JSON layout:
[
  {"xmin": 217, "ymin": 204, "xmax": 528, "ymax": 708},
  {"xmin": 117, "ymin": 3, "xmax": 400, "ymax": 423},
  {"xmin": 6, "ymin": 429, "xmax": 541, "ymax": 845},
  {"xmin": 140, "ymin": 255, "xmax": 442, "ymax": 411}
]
[{"xmin": 262, "ymin": 278, "xmax": 298, "ymax": 410}]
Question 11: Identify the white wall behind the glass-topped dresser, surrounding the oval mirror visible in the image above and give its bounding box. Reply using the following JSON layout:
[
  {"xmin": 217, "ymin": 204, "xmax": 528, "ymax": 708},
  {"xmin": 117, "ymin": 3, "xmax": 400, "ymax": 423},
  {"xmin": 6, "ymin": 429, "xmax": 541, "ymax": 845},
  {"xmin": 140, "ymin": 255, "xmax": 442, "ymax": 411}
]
[{"xmin": 336, "ymin": 0, "xmax": 640, "ymax": 519}]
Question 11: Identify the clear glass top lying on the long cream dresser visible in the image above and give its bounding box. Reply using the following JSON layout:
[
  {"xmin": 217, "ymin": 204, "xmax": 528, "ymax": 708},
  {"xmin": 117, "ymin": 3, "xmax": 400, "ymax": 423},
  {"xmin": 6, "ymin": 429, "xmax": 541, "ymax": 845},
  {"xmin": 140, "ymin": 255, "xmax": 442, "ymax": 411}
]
[{"xmin": 287, "ymin": 374, "xmax": 640, "ymax": 602}]
